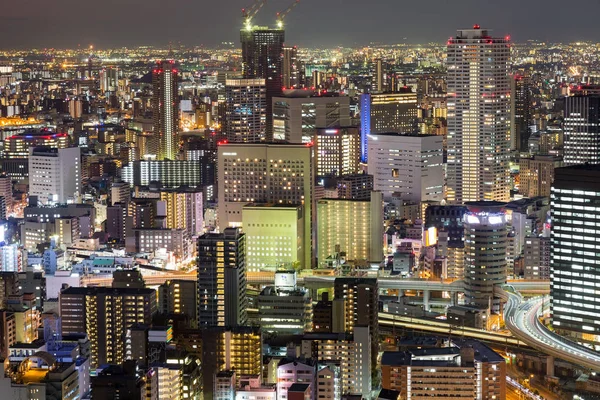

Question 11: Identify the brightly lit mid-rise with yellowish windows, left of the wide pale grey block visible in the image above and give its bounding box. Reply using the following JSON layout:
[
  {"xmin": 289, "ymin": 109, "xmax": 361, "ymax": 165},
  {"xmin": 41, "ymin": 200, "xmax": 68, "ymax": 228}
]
[{"xmin": 313, "ymin": 127, "xmax": 360, "ymax": 177}]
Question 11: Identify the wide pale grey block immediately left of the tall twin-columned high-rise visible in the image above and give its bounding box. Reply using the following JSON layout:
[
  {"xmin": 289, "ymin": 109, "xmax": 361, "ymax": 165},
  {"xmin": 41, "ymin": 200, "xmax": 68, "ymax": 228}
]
[{"xmin": 368, "ymin": 133, "xmax": 444, "ymax": 204}]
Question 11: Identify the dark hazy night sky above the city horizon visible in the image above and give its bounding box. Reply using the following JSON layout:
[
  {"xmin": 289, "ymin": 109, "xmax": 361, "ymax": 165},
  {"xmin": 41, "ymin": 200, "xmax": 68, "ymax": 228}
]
[{"xmin": 0, "ymin": 0, "xmax": 600, "ymax": 49}]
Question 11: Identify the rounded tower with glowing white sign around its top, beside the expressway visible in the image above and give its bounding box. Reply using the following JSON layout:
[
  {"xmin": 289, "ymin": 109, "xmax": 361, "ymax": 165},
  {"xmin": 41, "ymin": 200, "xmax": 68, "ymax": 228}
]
[{"xmin": 464, "ymin": 201, "xmax": 508, "ymax": 313}]
